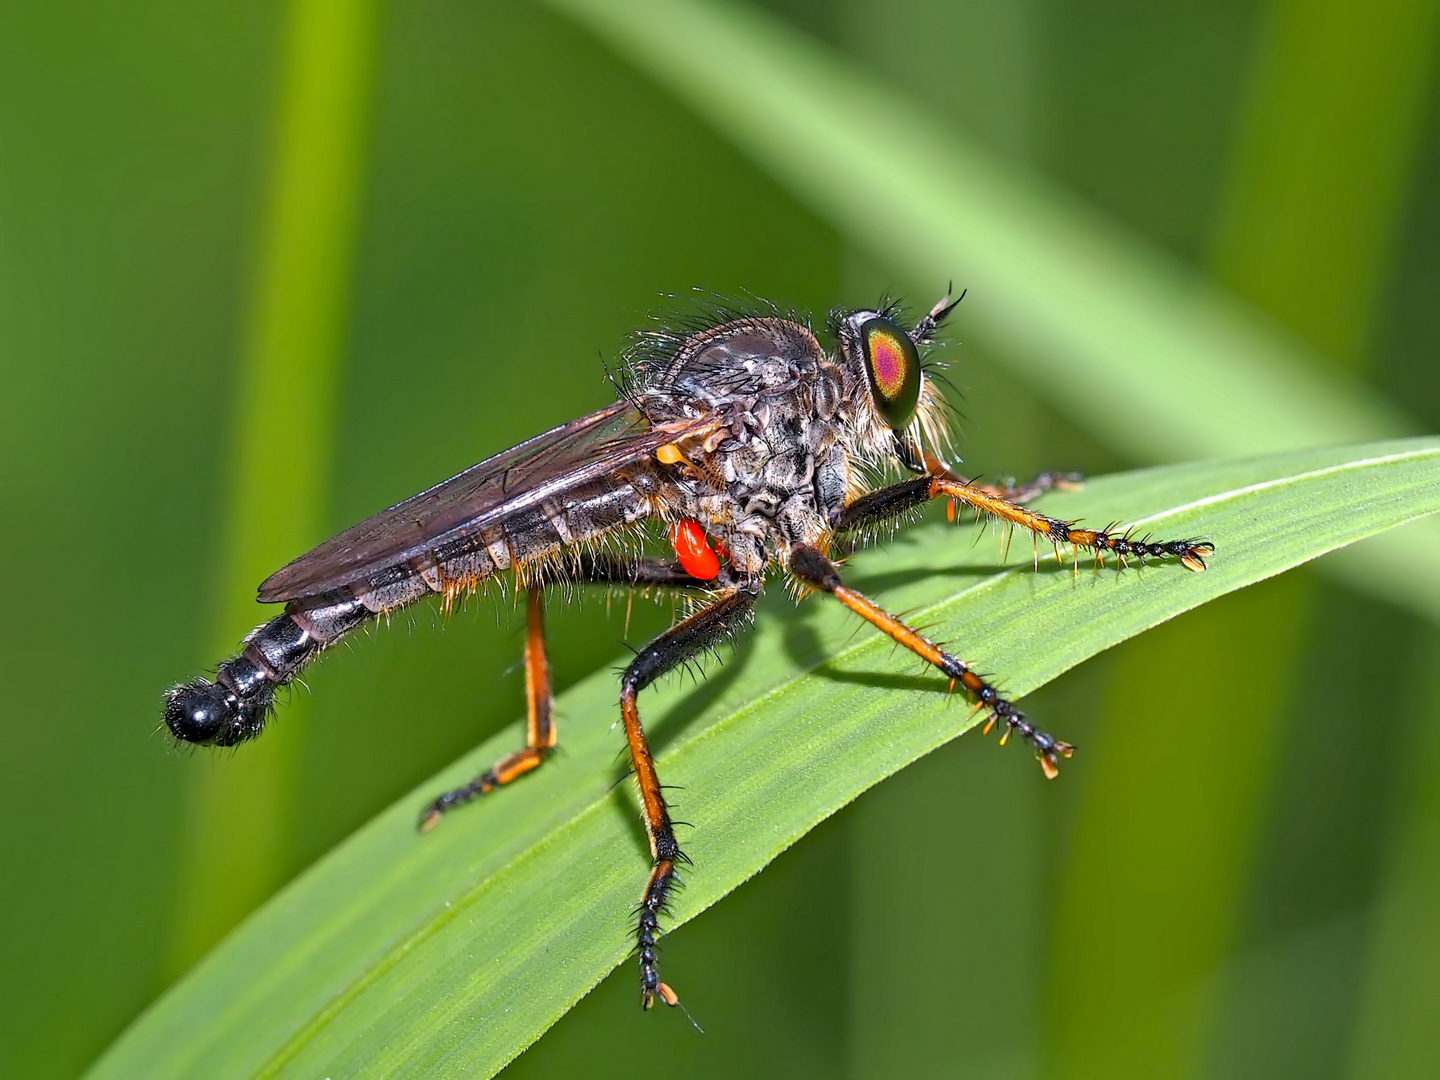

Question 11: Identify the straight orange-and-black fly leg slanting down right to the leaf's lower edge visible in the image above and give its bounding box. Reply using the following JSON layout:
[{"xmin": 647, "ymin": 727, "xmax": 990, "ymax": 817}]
[{"xmin": 789, "ymin": 544, "xmax": 1074, "ymax": 779}]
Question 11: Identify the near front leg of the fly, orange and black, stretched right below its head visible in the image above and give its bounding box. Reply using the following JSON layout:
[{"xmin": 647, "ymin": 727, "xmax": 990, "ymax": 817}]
[{"xmin": 831, "ymin": 475, "xmax": 1215, "ymax": 572}]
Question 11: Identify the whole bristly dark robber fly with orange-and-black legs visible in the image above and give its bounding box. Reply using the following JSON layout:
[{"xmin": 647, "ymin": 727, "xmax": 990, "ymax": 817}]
[{"xmin": 166, "ymin": 295, "xmax": 1214, "ymax": 1008}]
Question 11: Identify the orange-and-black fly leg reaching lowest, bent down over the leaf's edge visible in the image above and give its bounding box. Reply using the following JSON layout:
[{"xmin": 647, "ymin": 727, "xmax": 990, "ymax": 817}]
[{"xmin": 621, "ymin": 580, "xmax": 760, "ymax": 1009}]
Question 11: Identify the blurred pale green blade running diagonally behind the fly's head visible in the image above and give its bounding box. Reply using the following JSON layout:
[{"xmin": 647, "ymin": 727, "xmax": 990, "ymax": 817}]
[{"xmin": 550, "ymin": 0, "xmax": 1440, "ymax": 619}]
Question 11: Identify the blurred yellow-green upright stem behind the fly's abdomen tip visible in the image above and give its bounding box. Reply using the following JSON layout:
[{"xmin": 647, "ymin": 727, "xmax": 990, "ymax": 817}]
[{"xmin": 168, "ymin": 0, "xmax": 377, "ymax": 972}]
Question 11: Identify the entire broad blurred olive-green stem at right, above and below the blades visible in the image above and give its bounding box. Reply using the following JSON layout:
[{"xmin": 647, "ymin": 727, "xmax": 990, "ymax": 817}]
[{"xmin": 1050, "ymin": 0, "xmax": 1430, "ymax": 1076}]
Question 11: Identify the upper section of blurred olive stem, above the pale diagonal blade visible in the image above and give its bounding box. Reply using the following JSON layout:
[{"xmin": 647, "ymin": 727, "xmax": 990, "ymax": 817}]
[{"xmin": 1211, "ymin": 0, "xmax": 1440, "ymax": 370}]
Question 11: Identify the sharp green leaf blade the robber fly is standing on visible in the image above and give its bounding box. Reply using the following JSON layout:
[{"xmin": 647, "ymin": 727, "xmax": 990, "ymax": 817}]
[{"xmin": 94, "ymin": 439, "xmax": 1440, "ymax": 1077}]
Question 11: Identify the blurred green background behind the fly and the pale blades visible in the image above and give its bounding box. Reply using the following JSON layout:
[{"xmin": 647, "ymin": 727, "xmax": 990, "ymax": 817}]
[{"xmin": 0, "ymin": 0, "xmax": 1440, "ymax": 1077}]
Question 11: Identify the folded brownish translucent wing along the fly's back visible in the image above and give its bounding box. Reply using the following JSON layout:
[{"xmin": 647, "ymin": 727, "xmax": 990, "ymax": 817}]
[{"xmin": 259, "ymin": 402, "xmax": 714, "ymax": 603}]
